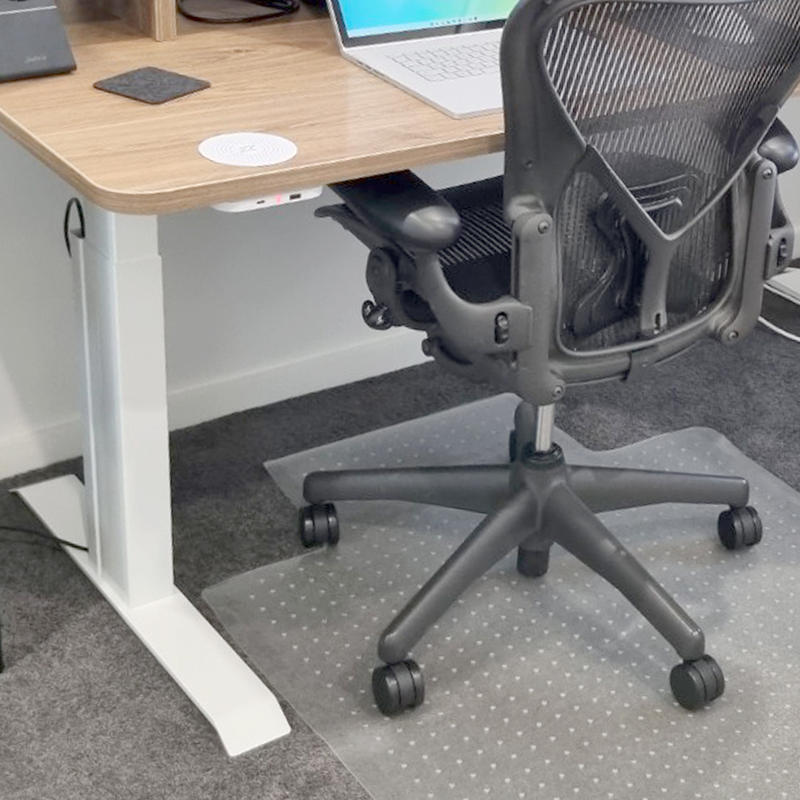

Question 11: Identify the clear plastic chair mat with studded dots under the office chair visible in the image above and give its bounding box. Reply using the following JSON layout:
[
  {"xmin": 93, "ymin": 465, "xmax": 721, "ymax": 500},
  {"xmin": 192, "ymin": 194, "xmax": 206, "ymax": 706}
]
[{"xmin": 203, "ymin": 395, "xmax": 800, "ymax": 800}]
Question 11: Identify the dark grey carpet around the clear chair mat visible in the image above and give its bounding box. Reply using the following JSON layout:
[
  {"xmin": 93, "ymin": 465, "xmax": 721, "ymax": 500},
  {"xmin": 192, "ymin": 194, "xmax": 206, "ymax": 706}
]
[{"xmin": 0, "ymin": 324, "xmax": 800, "ymax": 800}]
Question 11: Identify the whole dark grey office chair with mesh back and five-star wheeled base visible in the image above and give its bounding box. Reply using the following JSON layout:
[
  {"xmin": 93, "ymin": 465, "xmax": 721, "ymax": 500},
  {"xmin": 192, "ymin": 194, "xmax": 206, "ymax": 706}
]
[{"xmin": 300, "ymin": 0, "xmax": 800, "ymax": 714}]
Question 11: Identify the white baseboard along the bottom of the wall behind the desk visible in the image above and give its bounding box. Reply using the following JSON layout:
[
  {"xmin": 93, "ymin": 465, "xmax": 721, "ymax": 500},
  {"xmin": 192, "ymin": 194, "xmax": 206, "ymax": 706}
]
[{"xmin": 0, "ymin": 330, "xmax": 425, "ymax": 478}]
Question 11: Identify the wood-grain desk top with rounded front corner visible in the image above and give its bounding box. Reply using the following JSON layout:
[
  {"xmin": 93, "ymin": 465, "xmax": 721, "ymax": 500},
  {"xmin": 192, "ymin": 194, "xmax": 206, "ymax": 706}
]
[{"xmin": 0, "ymin": 14, "xmax": 503, "ymax": 214}]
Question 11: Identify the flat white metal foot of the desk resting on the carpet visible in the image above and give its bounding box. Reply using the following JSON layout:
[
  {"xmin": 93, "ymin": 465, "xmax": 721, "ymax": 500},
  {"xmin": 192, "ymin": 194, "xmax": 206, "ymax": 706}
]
[{"xmin": 16, "ymin": 475, "xmax": 290, "ymax": 756}]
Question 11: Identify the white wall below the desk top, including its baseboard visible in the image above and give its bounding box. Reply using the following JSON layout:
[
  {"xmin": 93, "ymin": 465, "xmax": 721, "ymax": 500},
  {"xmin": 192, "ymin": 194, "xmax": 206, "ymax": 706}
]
[{"xmin": 0, "ymin": 135, "xmax": 502, "ymax": 477}]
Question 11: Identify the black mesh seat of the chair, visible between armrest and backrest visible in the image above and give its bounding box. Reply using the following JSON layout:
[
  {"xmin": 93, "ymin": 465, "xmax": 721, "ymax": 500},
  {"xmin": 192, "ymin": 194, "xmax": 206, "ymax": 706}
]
[{"xmin": 439, "ymin": 175, "xmax": 511, "ymax": 303}]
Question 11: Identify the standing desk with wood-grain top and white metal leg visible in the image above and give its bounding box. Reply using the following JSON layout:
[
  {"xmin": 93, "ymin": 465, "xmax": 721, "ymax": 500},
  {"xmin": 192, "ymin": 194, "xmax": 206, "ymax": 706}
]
[{"xmin": 0, "ymin": 13, "xmax": 503, "ymax": 755}]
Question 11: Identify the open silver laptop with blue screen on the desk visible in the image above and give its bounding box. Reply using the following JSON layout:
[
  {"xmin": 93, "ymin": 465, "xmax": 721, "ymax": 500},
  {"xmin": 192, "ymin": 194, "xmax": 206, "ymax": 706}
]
[{"xmin": 328, "ymin": 0, "xmax": 517, "ymax": 118}]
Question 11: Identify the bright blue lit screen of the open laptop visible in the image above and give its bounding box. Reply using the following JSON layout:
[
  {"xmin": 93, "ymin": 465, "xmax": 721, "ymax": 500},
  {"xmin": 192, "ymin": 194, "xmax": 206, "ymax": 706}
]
[{"xmin": 331, "ymin": 0, "xmax": 517, "ymax": 45}]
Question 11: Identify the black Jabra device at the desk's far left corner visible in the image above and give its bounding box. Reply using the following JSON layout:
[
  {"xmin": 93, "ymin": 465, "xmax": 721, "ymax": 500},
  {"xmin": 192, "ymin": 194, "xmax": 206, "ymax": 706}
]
[{"xmin": 0, "ymin": 0, "xmax": 75, "ymax": 81}]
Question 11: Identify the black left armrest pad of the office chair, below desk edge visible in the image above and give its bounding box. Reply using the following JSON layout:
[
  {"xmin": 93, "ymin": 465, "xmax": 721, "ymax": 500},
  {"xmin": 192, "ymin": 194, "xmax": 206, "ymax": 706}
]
[{"xmin": 331, "ymin": 171, "xmax": 461, "ymax": 252}]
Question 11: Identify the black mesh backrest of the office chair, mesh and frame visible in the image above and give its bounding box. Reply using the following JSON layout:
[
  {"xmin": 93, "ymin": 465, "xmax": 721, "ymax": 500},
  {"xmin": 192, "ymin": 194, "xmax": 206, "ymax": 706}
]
[{"xmin": 502, "ymin": 0, "xmax": 800, "ymax": 362}]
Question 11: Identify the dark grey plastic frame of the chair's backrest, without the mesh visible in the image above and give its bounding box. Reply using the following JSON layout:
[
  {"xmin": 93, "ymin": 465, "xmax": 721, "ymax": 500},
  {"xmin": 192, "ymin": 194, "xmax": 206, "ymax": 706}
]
[{"xmin": 501, "ymin": 0, "xmax": 800, "ymax": 404}]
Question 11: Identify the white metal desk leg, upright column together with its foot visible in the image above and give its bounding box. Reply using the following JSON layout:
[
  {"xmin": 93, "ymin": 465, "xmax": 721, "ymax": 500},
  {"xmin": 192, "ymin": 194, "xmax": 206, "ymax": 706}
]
[{"xmin": 13, "ymin": 201, "xmax": 289, "ymax": 755}]
